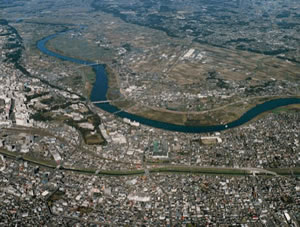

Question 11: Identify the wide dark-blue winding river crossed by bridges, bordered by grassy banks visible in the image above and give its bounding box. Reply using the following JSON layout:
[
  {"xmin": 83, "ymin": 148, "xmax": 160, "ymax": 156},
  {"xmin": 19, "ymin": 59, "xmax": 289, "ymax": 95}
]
[{"xmin": 37, "ymin": 32, "xmax": 300, "ymax": 133}]
